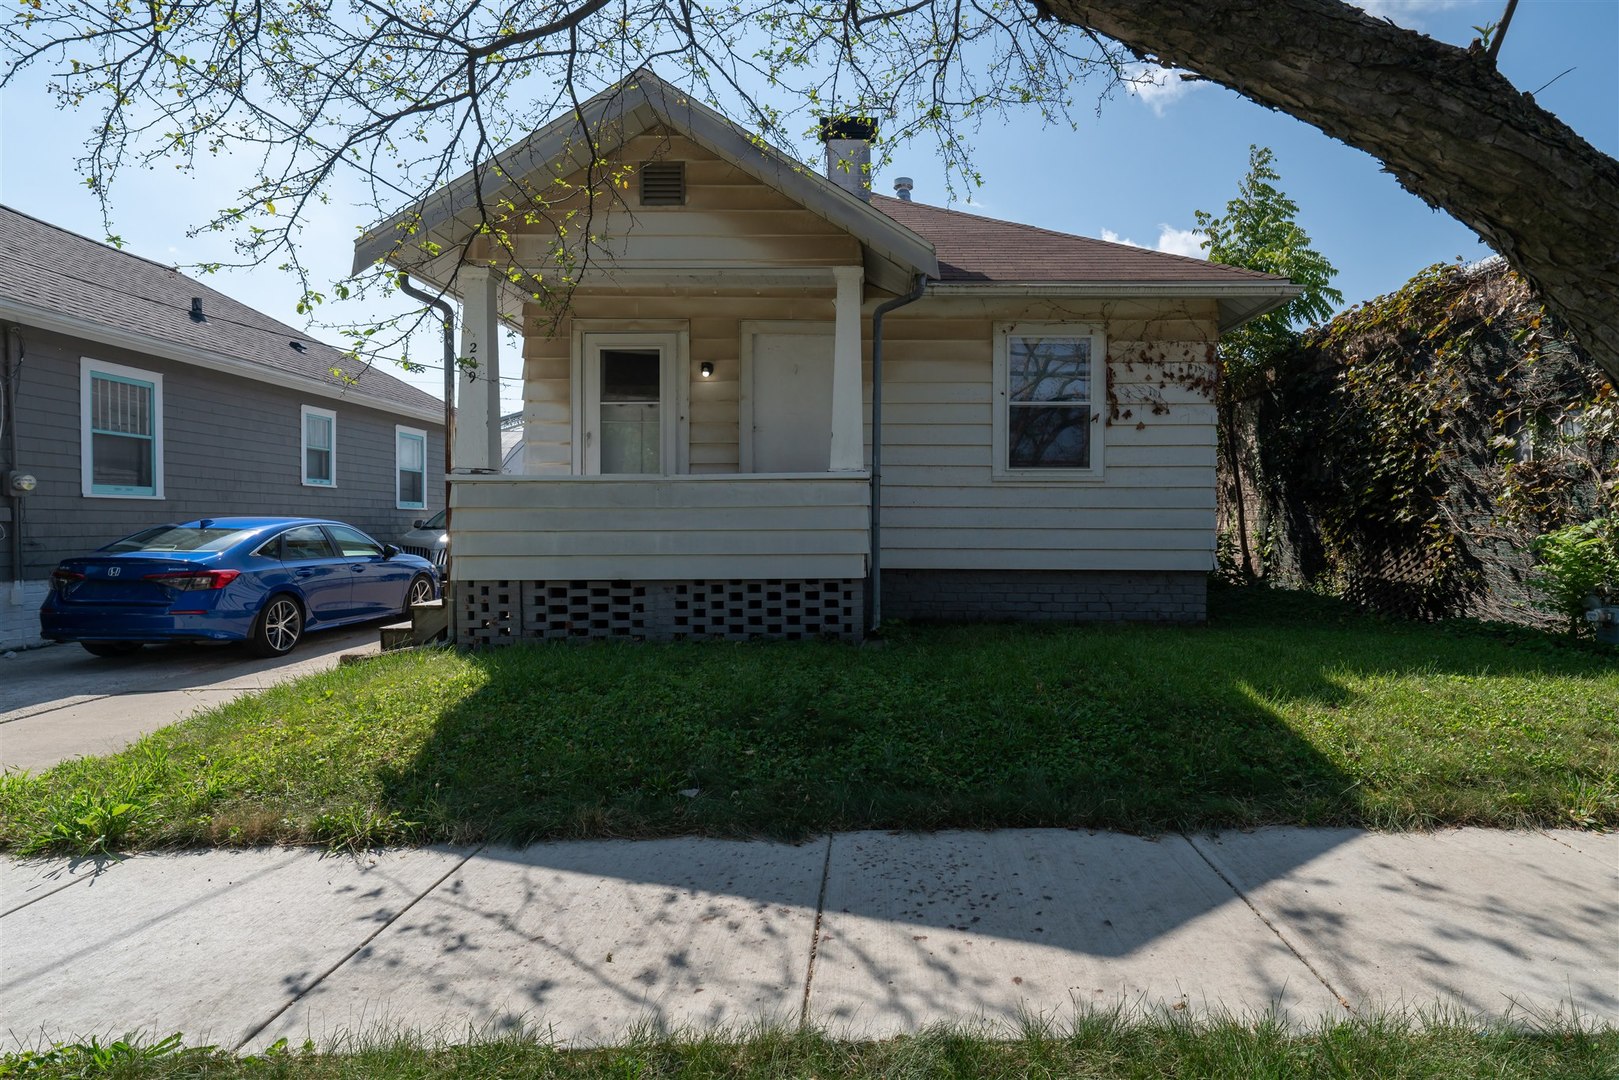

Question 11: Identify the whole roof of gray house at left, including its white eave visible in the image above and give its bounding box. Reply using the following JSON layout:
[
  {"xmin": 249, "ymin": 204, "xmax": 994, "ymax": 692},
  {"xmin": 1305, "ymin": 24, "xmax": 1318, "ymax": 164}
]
[{"xmin": 0, "ymin": 206, "xmax": 444, "ymax": 424}]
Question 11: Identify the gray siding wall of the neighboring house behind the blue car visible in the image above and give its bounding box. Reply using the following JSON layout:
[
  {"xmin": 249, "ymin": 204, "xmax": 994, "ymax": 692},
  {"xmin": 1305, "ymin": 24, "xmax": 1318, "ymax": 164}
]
[{"xmin": 0, "ymin": 327, "xmax": 444, "ymax": 581}]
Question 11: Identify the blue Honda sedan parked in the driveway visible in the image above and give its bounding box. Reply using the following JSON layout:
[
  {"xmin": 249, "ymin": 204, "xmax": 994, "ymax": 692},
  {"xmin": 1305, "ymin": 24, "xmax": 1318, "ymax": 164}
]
[{"xmin": 39, "ymin": 518, "xmax": 437, "ymax": 656}]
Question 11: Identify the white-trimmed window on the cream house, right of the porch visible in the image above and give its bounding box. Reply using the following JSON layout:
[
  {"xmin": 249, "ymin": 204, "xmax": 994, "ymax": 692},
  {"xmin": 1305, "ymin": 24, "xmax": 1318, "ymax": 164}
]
[{"xmin": 992, "ymin": 322, "xmax": 1107, "ymax": 479}]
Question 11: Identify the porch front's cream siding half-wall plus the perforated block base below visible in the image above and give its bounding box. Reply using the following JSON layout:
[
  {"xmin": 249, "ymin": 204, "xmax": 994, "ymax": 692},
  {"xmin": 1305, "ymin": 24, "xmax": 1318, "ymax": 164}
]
[{"xmin": 450, "ymin": 471, "xmax": 871, "ymax": 646}]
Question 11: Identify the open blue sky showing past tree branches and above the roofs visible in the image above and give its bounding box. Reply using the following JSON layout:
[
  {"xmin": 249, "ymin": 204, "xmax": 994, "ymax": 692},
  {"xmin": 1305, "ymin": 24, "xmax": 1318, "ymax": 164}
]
[{"xmin": 0, "ymin": 0, "xmax": 1619, "ymax": 410}]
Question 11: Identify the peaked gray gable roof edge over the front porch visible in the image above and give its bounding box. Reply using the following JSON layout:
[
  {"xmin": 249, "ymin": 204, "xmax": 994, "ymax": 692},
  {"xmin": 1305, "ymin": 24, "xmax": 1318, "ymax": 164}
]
[{"xmin": 355, "ymin": 70, "xmax": 939, "ymax": 286}]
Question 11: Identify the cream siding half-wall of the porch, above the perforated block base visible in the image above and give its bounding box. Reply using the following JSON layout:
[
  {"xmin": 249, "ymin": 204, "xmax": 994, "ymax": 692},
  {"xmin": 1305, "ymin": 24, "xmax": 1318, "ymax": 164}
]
[{"xmin": 452, "ymin": 474, "xmax": 869, "ymax": 581}]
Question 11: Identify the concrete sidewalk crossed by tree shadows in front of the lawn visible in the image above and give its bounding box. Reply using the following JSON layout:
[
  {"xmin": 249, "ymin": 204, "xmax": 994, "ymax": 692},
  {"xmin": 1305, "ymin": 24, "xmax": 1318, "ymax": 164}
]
[{"xmin": 0, "ymin": 829, "xmax": 1619, "ymax": 1049}]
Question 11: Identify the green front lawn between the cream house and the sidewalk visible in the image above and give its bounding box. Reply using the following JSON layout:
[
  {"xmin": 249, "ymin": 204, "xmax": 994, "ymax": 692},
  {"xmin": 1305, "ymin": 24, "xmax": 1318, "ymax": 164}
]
[{"xmin": 0, "ymin": 589, "xmax": 1619, "ymax": 852}]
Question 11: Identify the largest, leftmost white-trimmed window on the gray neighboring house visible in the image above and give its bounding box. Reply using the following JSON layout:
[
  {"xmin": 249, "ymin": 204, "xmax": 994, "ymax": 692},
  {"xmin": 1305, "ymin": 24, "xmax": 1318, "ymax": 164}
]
[{"xmin": 79, "ymin": 356, "xmax": 164, "ymax": 499}]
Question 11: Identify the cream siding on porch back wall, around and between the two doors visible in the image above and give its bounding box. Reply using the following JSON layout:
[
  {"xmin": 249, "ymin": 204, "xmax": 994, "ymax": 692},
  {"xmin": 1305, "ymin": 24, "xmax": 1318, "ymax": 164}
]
[{"xmin": 523, "ymin": 287, "xmax": 834, "ymax": 476}]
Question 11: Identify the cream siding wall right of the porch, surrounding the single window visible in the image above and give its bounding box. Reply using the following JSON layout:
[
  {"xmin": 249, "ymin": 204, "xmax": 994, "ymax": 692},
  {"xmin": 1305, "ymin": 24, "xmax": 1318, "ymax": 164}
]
[{"xmin": 866, "ymin": 301, "xmax": 1216, "ymax": 570}]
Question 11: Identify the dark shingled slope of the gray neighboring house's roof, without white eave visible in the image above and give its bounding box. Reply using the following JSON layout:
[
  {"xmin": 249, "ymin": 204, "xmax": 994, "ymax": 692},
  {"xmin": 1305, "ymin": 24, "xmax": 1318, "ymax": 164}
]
[{"xmin": 0, "ymin": 206, "xmax": 444, "ymax": 410}]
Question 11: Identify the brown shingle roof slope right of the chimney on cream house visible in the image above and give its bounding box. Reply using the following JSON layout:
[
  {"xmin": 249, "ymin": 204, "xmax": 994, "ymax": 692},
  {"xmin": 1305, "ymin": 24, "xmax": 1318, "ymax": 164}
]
[{"xmin": 871, "ymin": 194, "xmax": 1287, "ymax": 285}]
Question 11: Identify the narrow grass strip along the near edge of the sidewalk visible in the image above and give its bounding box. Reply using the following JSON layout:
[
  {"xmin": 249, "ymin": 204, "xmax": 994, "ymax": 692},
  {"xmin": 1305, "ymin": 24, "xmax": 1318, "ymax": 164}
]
[{"xmin": 0, "ymin": 1014, "xmax": 1619, "ymax": 1080}]
